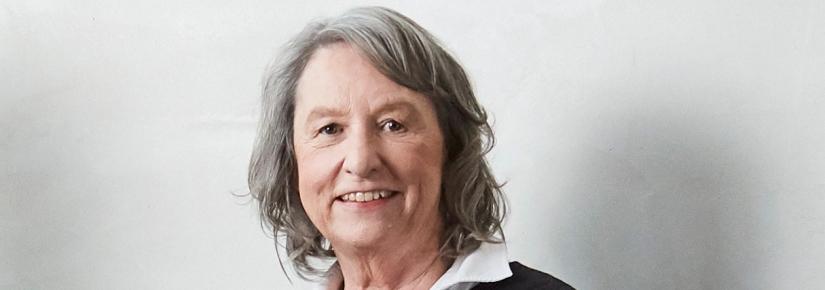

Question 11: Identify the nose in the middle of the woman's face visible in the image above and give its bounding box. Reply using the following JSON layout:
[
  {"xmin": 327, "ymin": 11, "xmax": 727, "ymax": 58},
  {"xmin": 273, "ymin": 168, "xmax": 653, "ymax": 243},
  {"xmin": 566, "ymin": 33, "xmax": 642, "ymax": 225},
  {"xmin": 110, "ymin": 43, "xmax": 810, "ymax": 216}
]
[{"xmin": 343, "ymin": 130, "xmax": 381, "ymax": 178}]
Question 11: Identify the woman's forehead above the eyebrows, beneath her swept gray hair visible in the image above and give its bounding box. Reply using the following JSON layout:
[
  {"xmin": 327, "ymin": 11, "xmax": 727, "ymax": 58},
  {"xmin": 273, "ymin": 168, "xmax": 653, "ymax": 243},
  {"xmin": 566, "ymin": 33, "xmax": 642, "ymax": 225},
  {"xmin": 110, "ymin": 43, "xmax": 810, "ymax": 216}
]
[{"xmin": 296, "ymin": 42, "xmax": 418, "ymax": 108}]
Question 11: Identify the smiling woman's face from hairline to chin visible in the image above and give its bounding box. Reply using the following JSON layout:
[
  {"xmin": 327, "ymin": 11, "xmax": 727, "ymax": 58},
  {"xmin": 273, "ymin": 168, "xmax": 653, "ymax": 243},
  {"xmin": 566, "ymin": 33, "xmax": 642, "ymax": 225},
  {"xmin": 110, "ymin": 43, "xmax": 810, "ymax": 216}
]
[{"xmin": 293, "ymin": 43, "xmax": 444, "ymax": 250}]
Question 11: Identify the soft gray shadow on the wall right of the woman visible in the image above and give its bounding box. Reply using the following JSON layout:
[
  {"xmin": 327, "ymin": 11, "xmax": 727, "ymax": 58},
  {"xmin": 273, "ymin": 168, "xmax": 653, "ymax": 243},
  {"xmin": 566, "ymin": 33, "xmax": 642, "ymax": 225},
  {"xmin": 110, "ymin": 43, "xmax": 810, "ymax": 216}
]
[{"xmin": 549, "ymin": 88, "xmax": 773, "ymax": 289}]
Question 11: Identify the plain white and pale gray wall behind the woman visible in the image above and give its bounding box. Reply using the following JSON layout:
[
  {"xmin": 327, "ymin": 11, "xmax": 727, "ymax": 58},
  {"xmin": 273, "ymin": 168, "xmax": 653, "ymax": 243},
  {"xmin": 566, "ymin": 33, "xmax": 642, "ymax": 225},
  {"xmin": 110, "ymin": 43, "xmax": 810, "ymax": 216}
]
[{"xmin": 0, "ymin": 0, "xmax": 825, "ymax": 289}]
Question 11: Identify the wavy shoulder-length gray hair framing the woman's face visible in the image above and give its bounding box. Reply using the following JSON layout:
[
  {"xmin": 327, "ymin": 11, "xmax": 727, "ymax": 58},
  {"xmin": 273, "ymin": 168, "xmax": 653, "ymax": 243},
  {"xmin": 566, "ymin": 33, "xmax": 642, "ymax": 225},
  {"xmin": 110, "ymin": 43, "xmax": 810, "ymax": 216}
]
[{"xmin": 248, "ymin": 7, "xmax": 506, "ymax": 279}]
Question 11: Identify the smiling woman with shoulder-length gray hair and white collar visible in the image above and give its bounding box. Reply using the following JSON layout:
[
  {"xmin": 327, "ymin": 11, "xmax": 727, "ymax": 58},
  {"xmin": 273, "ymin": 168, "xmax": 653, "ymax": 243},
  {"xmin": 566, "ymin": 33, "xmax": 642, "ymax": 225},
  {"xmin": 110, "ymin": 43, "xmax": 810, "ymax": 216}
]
[{"xmin": 249, "ymin": 7, "xmax": 570, "ymax": 289}]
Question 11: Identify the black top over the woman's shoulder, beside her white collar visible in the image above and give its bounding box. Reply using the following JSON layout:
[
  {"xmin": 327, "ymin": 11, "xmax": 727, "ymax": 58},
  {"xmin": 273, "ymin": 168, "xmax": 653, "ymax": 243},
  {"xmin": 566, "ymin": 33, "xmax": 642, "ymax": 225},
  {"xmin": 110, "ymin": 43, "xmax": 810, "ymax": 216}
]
[{"xmin": 472, "ymin": 262, "xmax": 574, "ymax": 290}]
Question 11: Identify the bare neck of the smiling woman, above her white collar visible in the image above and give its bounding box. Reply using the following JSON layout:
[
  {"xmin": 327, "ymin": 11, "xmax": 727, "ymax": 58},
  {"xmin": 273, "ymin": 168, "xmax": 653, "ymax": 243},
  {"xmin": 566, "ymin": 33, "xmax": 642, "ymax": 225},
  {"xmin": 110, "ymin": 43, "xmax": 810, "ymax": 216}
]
[{"xmin": 335, "ymin": 229, "xmax": 448, "ymax": 289}]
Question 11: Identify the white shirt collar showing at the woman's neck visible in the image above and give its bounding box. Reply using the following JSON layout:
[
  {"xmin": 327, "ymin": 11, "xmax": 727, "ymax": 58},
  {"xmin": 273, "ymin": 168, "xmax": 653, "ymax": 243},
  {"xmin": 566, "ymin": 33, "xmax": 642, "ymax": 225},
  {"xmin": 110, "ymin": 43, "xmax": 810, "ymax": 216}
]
[{"xmin": 315, "ymin": 242, "xmax": 513, "ymax": 290}]
